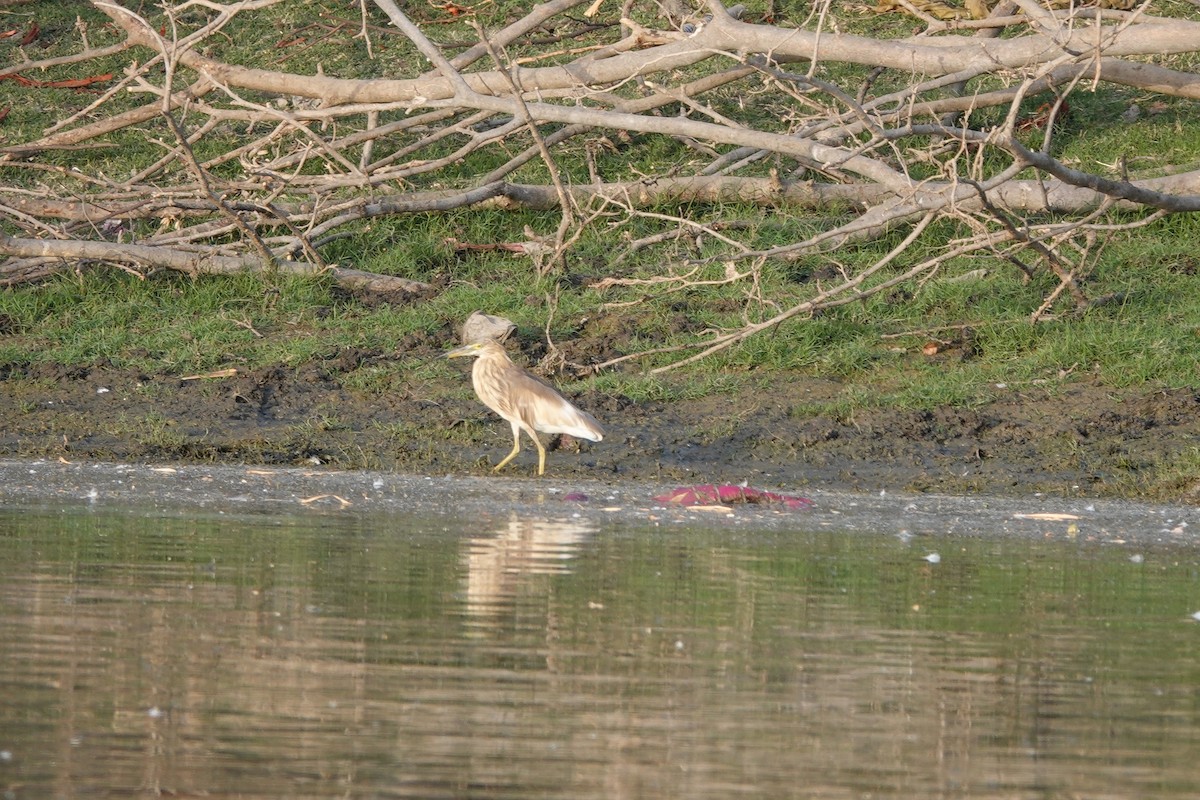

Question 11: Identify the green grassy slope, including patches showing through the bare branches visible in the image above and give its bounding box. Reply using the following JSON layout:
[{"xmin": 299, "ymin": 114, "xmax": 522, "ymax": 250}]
[{"xmin": 0, "ymin": 1, "xmax": 1200, "ymax": 496}]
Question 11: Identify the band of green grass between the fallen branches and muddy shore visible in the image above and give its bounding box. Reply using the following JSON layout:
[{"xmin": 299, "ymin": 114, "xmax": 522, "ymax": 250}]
[{"xmin": 7, "ymin": 203, "xmax": 1200, "ymax": 408}]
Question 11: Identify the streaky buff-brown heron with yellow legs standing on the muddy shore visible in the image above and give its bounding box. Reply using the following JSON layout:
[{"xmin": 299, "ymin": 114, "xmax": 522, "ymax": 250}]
[{"xmin": 444, "ymin": 339, "xmax": 604, "ymax": 475}]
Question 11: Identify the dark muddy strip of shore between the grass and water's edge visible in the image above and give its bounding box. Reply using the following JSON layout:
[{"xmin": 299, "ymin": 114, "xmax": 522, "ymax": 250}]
[{"xmin": 0, "ymin": 350, "xmax": 1200, "ymax": 501}]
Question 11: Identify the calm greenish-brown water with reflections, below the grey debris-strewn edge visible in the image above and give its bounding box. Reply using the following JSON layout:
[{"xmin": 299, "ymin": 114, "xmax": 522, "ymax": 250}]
[{"xmin": 0, "ymin": 509, "xmax": 1200, "ymax": 800}]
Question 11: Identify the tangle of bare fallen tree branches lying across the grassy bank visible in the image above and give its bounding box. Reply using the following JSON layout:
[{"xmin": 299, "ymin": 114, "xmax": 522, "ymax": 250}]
[{"xmin": 0, "ymin": 0, "xmax": 1200, "ymax": 368}]
